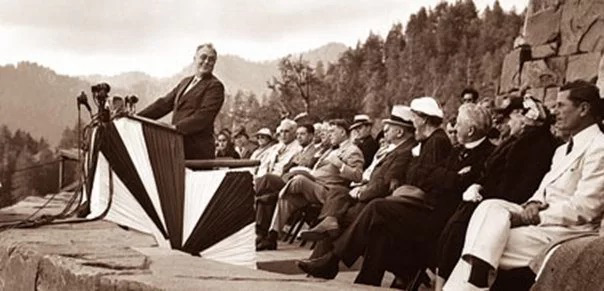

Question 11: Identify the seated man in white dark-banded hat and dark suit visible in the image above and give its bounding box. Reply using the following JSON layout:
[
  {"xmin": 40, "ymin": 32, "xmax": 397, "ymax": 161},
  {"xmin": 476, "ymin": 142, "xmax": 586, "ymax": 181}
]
[{"xmin": 300, "ymin": 105, "xmax": 415, "ymax": 242}]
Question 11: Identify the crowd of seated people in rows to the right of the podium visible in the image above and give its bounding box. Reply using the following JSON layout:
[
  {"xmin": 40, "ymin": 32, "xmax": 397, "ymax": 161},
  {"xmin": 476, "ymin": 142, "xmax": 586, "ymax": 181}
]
[{"xmin": 217, "ymin": 81, "xmax": 604, "ymax": 290}]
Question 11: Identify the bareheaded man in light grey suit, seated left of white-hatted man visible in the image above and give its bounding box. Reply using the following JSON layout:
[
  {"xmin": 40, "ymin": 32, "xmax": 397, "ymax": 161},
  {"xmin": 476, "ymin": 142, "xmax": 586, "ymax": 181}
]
[{"xmin": 256, "ymin": 119, "xmax": 363, "ymax": 250}]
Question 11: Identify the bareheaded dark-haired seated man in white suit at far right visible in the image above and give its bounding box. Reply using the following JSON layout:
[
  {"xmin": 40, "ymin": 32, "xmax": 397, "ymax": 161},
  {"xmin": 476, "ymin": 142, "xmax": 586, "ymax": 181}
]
[{"xmin": 444, "ymin": 81, "xmax": 604, "ymax": 290}]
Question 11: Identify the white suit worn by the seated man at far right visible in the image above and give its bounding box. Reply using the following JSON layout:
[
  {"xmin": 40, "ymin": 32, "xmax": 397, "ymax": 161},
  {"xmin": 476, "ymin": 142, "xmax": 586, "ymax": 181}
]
[{"xmin": 444, "ymin": 124, "xmax": 604, "ymax": 290}]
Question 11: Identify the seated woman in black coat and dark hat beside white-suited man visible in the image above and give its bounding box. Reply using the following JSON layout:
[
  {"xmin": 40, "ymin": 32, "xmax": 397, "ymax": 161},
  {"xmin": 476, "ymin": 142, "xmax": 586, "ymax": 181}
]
[{"xmin": 437, "ymin": 97, "xmax": 556, "ymax": 290}]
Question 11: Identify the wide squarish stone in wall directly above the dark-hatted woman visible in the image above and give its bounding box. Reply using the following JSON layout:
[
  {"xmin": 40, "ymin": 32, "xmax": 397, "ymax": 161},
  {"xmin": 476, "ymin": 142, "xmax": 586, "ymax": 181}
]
[{"xmin": 521, "ymin": 57, "xmax": 566, "ymax": 88}]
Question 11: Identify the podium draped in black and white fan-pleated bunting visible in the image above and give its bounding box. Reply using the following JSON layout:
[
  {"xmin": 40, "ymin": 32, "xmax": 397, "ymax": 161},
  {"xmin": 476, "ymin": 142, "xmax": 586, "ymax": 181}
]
[{"xmin": 85, "ymin": 116, "xmax": 255, "ymax": 267}]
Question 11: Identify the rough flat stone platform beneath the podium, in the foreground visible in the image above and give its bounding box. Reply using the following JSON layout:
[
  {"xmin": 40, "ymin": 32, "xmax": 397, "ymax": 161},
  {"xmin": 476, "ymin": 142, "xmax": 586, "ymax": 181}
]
[{"xmin": 0, "ymin": 193, "xmax": 392, "ymax": 291}]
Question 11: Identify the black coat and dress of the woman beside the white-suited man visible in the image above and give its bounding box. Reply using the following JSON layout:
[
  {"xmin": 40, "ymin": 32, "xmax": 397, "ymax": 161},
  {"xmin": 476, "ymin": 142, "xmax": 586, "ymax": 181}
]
[{"xmin": 437, "ymin": 125, "xmax": 557, "ymax": 279}]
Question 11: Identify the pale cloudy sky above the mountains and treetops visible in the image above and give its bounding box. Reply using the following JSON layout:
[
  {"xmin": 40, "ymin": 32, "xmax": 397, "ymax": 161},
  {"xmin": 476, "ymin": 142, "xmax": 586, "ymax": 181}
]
[{"xmin": 0, "ymin": 0, "xmax": 529, "ymax": 77}]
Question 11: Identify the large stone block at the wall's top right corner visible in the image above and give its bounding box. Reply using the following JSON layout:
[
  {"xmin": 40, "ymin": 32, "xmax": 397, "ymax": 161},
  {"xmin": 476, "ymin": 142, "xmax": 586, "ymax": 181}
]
[{"xmin": 559, "ymin": 0, "xmax": 604, "ymax": 55}]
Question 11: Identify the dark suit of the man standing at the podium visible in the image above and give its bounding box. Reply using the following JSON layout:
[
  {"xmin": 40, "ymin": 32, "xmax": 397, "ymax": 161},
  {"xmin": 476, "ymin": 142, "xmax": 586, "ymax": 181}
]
[{"xmin": 139, "ymin": 74, "xmax": 224, "ymax": 159}]
